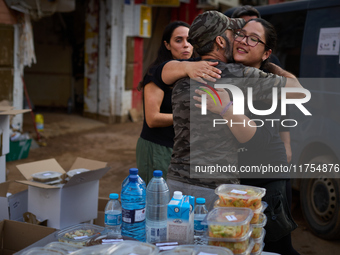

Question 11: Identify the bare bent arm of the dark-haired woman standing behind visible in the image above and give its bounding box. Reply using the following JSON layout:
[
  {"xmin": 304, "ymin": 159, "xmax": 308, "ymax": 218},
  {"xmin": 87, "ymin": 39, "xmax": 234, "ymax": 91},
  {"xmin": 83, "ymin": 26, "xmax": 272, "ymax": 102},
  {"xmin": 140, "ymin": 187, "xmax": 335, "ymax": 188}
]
[{"xmin": 144, "ymin": 82, "xmax": 173, "ymax": 128}]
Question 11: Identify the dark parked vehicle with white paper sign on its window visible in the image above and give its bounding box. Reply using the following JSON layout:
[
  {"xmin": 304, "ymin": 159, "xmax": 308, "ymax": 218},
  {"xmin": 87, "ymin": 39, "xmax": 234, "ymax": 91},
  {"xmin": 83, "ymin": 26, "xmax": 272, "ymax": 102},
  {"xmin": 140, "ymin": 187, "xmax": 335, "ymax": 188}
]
[{"xmin": 225, "ymin": 0, "xmax": 340, "ymax": 239}]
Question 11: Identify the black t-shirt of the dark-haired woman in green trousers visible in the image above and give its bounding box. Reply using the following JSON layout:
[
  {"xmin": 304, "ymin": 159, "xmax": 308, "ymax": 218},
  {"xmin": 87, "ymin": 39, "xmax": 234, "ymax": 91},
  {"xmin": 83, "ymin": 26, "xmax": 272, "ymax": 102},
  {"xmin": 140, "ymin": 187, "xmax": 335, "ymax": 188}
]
[{"xmin": 140, "ymin": 66, "xmax": 175, "ymax": 148}]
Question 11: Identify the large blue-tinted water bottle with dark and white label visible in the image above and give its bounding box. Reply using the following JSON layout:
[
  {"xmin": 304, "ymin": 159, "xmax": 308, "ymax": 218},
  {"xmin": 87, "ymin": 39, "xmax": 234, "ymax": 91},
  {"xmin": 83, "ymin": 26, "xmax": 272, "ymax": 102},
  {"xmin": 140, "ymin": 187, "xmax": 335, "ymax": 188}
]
[{"xmin": 120, "ymin": 175, "xmax": 146, "ymax": 242}]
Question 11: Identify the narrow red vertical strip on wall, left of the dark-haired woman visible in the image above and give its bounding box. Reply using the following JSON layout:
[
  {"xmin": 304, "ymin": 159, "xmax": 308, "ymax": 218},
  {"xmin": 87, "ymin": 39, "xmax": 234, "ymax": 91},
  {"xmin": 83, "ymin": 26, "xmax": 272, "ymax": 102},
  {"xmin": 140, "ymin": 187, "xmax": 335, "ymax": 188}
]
[{"xmin": 132, "ymin": 37, "xmax": 144, "ymax": 109}]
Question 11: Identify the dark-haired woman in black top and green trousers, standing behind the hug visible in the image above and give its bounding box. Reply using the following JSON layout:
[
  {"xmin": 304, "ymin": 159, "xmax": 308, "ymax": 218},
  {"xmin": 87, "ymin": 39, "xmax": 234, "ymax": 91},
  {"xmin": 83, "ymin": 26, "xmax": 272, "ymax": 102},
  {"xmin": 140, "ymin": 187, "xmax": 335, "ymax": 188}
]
[{"xmin": 136, "ymin": 21, "xmax": 193, "ymax": 184}]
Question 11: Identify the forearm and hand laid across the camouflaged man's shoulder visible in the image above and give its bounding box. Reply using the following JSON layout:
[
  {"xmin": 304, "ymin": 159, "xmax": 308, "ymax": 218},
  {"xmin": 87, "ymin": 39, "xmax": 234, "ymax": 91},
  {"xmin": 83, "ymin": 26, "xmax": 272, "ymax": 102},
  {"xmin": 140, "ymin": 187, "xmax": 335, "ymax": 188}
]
[{"xmin": 162, "ymin": 60, "xmax": 221, "ymax": 85}]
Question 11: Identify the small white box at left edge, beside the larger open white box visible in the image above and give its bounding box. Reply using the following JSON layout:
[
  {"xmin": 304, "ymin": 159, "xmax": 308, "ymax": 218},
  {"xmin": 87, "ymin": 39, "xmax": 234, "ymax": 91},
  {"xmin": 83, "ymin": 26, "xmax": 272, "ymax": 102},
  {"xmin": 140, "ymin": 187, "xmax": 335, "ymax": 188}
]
[{"xmin": 0, "ymin": 181, "xmax": 28, "ymax": 221}]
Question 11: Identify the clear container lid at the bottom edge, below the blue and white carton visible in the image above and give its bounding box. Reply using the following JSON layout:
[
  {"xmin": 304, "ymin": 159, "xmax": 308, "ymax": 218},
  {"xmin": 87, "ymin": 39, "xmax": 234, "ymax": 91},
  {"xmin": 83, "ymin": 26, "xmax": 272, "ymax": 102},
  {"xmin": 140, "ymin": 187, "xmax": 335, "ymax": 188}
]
[{"xmin": 161, "ymin": 245, "xmax": 233, "ymax": 255}]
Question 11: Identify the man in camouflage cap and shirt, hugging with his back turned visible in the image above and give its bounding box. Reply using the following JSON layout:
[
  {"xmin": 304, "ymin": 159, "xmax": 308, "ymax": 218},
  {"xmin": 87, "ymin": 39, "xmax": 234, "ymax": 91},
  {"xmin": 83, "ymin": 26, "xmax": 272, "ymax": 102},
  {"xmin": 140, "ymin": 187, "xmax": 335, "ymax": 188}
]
[{"xmin": 154, "ymin": 11, "xmax": 301, "ymax": 208}]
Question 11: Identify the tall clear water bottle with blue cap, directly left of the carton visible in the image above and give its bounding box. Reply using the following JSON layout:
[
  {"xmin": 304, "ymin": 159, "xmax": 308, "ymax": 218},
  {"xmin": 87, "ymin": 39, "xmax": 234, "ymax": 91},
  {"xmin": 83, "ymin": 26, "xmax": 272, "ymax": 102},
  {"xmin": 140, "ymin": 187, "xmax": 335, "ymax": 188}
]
[{"xmin": 145, "ymin": 170, "xmax": 170, "ymax": 243}]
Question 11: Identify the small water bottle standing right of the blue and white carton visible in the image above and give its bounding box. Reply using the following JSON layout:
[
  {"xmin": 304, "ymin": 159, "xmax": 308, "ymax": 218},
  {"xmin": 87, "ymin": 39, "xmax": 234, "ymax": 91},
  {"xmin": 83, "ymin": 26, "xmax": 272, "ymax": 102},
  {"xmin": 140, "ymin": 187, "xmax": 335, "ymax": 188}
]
[{"xmin": 194, "ymin": 197, "xmax": 208, "ymax": 244}]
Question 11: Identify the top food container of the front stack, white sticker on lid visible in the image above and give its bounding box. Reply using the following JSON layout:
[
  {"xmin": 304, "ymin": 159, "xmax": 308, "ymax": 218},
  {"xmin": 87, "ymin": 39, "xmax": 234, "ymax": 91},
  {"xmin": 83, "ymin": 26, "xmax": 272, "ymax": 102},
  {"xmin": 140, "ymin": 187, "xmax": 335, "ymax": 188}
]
[{"xmin": 202, "ymin": 207, "xmax": 253, "ymax": 238}]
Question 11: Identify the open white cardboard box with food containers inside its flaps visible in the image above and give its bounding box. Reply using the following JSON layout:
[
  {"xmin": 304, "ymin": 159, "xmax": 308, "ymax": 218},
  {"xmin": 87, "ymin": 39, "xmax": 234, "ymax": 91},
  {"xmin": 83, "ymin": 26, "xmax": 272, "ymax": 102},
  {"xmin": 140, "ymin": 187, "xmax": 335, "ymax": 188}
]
[{"xmin": 17, "ymin": 158, "xmax": 109, "ymax": 229}]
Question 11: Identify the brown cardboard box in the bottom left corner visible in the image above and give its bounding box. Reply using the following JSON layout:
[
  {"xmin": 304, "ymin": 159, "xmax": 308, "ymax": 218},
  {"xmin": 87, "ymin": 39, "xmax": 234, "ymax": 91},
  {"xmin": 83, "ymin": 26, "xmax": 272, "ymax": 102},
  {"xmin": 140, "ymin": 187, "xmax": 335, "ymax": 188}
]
[{"xmin": 0, "ymin": 220, "xmax": 56, "ymax": 255}]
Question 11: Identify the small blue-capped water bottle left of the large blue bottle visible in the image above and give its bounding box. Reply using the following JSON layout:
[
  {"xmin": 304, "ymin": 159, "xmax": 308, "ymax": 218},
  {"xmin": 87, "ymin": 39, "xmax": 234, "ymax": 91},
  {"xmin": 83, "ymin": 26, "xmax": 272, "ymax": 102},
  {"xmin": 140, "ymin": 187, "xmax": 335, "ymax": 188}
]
[{"xmin": 105, "ymin": 193, "xmax": 122, "ymax": 235}]
